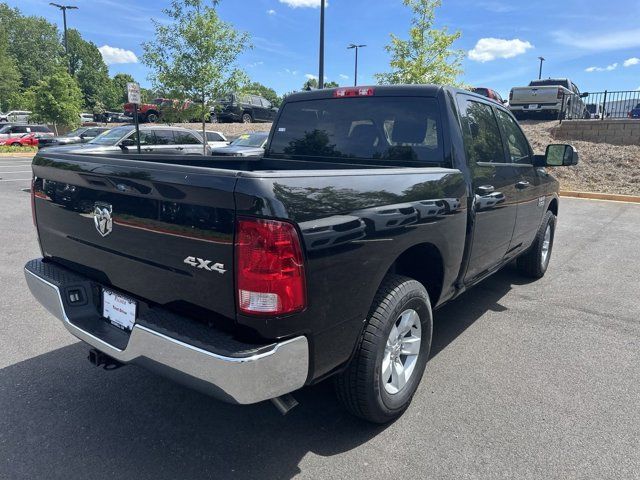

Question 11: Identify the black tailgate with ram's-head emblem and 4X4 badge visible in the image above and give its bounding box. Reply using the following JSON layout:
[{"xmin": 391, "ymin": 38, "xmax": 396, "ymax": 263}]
[{"xmin": 33, "ymin": 153, "xmax": 236, "ymax": 320}]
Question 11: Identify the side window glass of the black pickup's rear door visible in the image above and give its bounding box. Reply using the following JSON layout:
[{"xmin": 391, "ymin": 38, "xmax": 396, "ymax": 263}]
[{"xmin": 459, "ymin": 97, "xmax": 505, "ymax": 163}]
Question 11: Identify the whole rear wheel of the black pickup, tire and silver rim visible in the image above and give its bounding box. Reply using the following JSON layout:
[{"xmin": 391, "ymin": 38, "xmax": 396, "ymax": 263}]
[{"xmin": 335, "ymin": 275, "xmax": 433, "ymax": 423}]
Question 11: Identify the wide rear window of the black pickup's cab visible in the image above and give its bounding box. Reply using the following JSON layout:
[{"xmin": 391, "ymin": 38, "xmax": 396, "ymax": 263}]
[{"xmin": 269, "ymin": 97, "xmax": 444, "ymax": 165}]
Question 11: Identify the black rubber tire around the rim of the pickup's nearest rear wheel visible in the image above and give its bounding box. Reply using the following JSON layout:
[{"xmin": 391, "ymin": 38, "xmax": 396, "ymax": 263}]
[{"xmin": 335, "ymin": 275, "xmax": 433, "ymax": 424}]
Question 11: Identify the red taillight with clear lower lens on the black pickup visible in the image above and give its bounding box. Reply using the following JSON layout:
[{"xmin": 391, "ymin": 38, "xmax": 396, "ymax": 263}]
[{"xmin": 235, "ymin": 218, "xmax": 306, "ymax": 315}]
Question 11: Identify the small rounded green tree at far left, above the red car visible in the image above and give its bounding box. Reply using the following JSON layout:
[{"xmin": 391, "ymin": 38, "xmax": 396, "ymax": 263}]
[{"xmin": 30, "ymin": 68, "xmax": 82, "ymax": 130}]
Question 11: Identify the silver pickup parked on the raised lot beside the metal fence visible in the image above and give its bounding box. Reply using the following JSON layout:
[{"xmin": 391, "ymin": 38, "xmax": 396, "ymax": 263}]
[{"xmin": 509, "ymin": 78, "xmax": 591, "ymax": 119}]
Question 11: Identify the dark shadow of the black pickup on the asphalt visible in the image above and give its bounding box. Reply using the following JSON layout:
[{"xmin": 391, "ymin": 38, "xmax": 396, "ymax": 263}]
[{"xmin": 0, "ymin": 270, "xmax": 518, "ymax": 480}]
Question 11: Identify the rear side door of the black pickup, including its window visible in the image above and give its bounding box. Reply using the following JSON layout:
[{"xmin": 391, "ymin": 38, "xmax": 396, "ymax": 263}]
[{"xmin": 458, "ymin": 95, "xmax": 518, "ymax": 281}]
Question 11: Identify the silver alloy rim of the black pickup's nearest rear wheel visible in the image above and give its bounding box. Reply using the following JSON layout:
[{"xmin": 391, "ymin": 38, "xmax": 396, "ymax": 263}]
[{"xmin": 380, "ymin": 309, "xmax": 422, "ymax": 395}]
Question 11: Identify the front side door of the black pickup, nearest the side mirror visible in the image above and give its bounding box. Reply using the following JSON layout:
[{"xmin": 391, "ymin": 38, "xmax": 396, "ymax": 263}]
[{"xmin": 496, "ymin": 108, "xmax": 546, "ymax": 248}]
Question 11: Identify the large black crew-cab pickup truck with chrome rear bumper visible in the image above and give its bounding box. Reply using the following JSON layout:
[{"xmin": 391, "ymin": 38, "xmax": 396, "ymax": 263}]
[{"xmin": 25, "ymin": 86, "xmax": 578, "ymax": 423}]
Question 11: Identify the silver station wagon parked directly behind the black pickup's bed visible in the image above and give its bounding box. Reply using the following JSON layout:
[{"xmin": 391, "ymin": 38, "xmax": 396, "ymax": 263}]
[{"xmin": 47, "ymin": 125, "xmax": 211, "ymax": 155}]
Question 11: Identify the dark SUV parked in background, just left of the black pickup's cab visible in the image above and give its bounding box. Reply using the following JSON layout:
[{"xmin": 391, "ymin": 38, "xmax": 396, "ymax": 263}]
[{"xmin": 211, "ymin": 94, "xmax": 278, "ymax": 123}]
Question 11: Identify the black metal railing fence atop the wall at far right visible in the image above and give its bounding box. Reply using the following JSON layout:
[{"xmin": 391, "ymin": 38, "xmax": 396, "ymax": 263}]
[{"xmin": 558, "ymin": 90, "xmax": 640, "ymax": 123}]
